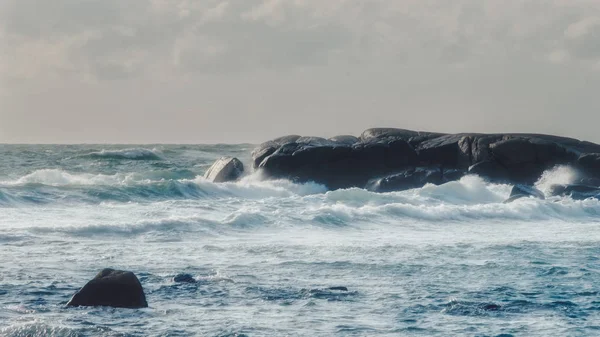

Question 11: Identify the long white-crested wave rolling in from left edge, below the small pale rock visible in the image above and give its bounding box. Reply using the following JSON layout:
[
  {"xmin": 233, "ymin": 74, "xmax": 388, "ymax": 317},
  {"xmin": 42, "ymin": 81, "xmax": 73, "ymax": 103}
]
[{"xmin": 0, "ymin": 169, "xmax": 326, "ymax": 205}]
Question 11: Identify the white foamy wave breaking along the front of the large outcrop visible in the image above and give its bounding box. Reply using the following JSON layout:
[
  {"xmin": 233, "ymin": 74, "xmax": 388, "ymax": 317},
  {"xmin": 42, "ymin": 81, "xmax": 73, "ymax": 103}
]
[{"xmin": 305, "ymin": 176, "xmax": 600, "ymax": 226}]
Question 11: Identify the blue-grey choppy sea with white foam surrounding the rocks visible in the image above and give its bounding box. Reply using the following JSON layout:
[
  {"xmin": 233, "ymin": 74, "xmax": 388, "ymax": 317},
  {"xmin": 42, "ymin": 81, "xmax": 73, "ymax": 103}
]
[{"xmin": 0, "ymin": 145, "xmax": 600, "ymax": 336}]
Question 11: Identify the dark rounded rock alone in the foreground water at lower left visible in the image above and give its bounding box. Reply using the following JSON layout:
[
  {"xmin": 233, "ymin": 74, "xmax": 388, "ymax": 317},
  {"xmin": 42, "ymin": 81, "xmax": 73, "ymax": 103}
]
[{"xmin": 67, "ymin": 268, "xmax": 148, "ymax": 308}]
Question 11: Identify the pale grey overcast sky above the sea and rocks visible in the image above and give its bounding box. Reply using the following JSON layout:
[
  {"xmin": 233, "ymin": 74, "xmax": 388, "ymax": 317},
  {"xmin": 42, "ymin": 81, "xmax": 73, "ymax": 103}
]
[{"xmin": 0, "ymin": 0, "xmax": 600, "ymax": 143}]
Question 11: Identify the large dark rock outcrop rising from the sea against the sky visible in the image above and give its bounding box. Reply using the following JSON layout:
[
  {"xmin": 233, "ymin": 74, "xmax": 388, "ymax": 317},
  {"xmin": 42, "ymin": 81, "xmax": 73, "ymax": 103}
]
[{"xmin": 252, "ymin": 128, "xmax": 600, "ymax": 190}]
